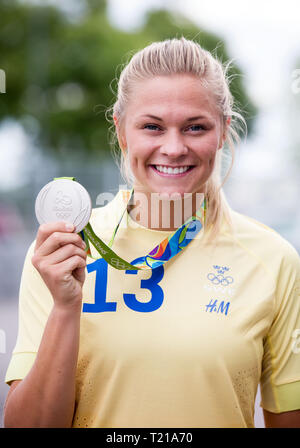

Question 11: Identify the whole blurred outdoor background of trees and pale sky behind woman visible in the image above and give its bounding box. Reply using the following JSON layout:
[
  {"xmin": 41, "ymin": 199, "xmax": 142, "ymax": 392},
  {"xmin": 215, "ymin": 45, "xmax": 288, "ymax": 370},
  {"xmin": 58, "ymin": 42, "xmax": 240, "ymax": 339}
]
[{"xmin": 0, "ymin": 0, "xmax": 300, "ymax": 427}]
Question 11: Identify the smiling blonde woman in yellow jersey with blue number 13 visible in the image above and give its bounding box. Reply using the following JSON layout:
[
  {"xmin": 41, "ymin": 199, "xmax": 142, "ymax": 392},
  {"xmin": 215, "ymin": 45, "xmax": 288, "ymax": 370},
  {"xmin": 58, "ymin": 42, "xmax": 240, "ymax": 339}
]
[{"xmin": 5, "ymin": 38, "xmax": 300, "ymax": 428}]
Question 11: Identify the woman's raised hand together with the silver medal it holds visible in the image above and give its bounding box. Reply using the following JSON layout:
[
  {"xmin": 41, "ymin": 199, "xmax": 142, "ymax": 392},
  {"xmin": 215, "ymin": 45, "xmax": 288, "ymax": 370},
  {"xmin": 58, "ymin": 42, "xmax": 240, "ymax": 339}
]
[{"xmin": 32, "ymin": 178, "xmax": 92, "ymax": 309}]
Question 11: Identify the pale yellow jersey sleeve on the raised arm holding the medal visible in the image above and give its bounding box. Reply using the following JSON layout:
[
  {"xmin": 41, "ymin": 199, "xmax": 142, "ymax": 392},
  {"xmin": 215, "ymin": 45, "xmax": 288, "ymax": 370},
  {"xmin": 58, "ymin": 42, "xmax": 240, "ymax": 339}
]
[{"xmin": 5, "ymin": 241, "xmax": 53, "ymax": 384}]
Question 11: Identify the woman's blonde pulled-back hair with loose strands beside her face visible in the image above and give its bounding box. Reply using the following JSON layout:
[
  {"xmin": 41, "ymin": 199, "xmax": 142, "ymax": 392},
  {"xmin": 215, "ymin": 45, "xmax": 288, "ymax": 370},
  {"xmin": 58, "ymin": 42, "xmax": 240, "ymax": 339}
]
[{"xmin": 108, "ymin": 37, "xmax": 247, "ymax": 241}]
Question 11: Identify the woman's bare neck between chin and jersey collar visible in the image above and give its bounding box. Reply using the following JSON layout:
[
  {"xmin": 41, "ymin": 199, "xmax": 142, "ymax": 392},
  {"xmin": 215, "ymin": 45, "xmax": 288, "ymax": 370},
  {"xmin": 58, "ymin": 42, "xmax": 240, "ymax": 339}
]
[{"xmin": 127, "ymin": 189, "xmax": 204, "ymax": 232}]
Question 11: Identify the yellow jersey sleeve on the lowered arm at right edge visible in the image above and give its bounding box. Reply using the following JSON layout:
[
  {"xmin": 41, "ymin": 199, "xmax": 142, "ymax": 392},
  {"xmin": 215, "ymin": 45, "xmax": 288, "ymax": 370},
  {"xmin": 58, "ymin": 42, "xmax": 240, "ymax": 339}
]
[{"xmin": 260, "ymin": 242, "xmax": 300, "ymax": 413}]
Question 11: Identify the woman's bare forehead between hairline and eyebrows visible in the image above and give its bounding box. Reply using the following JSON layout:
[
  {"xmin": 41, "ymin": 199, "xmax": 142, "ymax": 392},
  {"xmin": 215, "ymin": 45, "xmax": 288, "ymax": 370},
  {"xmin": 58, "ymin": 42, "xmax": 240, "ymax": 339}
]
[{"xmin": 126, "ymin": 74, "xmax": 218, "ymax": 118}]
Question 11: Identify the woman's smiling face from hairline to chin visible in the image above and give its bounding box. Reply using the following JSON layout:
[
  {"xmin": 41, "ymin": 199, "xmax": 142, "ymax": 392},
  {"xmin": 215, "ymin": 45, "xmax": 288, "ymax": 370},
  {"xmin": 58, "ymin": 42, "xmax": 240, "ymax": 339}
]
[{"xmin": 117, "ymin": 75, "xmax": 224, "ymax": 196}]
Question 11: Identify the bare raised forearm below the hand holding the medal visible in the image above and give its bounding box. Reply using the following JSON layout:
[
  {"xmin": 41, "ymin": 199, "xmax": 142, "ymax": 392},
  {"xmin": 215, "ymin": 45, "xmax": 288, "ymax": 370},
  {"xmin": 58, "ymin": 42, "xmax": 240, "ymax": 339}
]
[{"xmin": 4, "ymin": 304, "xmax": 81, "ymax": 427}]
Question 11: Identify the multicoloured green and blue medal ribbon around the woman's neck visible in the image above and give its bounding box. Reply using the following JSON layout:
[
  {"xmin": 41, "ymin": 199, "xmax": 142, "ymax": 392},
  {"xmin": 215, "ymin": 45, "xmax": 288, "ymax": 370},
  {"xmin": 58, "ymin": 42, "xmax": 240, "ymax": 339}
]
[{"xmin": 55, "ymin": 178, "xmax": 206, "ymax": 271}]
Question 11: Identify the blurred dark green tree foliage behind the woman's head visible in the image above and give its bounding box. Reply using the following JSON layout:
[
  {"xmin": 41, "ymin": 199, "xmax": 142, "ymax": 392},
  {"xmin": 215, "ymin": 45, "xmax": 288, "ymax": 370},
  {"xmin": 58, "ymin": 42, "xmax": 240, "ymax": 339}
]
[{"xmin": 0, "ymin": 0, "xmax": 256, "ymax": 156}]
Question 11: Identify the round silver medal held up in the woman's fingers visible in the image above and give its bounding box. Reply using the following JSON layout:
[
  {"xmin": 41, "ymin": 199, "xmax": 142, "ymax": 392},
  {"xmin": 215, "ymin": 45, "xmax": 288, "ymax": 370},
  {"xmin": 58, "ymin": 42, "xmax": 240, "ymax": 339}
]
[{"xmin": 35, "ymin": 179, "xmax": 92, "ymax": 233}]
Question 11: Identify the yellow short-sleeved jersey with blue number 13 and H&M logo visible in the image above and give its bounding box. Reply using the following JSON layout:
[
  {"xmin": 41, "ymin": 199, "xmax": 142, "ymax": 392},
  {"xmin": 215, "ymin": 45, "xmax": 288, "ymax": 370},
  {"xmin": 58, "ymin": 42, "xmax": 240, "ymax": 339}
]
[{"xmin": 6, "ymin": 191, "xmax": 300, "ymax": 428}]
